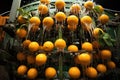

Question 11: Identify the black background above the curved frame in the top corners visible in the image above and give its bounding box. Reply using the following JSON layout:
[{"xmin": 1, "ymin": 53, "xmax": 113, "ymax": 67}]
[{"xmin": 0, "ymin": 0, "xmax": 120, "ymax": 14}]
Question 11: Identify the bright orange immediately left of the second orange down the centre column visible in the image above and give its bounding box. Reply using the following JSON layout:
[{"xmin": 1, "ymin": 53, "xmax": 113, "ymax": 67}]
[{"xmin": 43, "ymin": 17, "xmax": 54, "ymax": 29}]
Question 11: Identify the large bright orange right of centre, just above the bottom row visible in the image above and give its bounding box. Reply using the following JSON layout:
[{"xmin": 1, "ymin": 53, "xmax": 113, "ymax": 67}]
[{"xmin": 78, "ymin": 53, "xmax": 91, "ymax": 66}]
